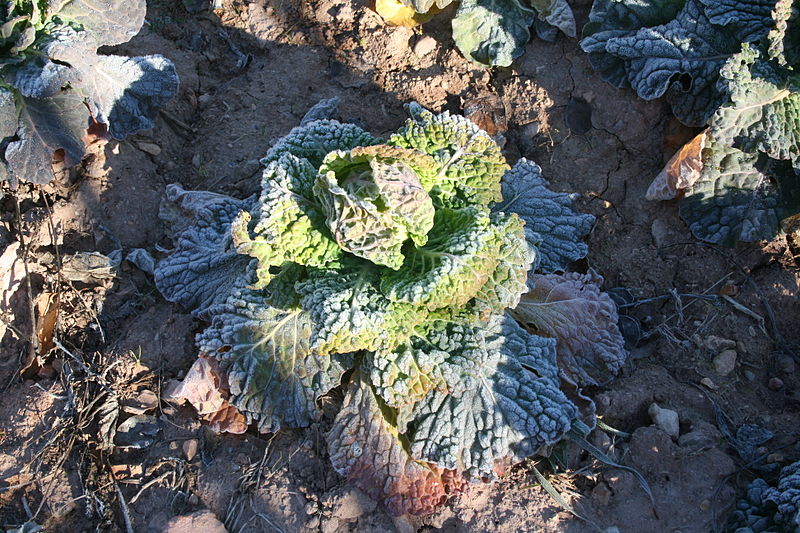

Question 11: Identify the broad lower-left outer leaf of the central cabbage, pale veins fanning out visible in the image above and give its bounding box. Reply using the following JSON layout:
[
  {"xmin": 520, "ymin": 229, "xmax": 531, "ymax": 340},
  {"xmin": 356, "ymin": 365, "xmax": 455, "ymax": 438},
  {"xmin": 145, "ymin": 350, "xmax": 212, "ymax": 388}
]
[{"xmin": 197, "ymin": 289, "xmax": 352, "ymax": 432}]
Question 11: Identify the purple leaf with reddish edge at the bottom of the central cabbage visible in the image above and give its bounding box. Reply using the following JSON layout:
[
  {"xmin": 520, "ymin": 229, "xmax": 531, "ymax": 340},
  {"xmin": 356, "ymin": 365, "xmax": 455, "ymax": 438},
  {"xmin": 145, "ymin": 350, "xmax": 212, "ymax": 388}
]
[{"xmin": 327, "ymin": 378, "xmax": 464, "ymax": 516}]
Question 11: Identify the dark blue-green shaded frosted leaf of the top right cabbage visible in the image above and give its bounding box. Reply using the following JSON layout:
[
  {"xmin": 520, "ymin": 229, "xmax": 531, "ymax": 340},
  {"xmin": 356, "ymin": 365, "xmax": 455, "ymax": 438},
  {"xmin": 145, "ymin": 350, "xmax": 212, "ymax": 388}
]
[{"xmin": 581, "ymin": 0, "xmax": 771, "ymax": 126}]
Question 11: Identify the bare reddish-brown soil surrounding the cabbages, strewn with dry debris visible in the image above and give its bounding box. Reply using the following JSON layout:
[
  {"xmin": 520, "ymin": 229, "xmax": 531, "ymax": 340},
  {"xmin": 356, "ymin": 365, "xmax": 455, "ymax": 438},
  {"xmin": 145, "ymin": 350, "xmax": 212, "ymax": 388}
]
[{"xmin": 0, "ymin": 0, "xmax": 800, "ymax": 533}]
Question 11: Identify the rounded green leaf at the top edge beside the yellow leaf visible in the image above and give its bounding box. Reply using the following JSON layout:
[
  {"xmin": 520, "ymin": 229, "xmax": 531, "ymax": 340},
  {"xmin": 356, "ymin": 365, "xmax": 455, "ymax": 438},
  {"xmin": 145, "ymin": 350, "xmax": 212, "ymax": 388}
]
[{"xmin": 453, "ymin": 0, "xmax": 536, "ymax": 67}]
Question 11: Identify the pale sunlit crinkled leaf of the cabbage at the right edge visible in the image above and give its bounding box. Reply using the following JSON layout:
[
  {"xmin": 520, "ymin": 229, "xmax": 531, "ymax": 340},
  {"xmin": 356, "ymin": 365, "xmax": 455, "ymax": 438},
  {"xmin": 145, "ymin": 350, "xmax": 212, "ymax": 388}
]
[{"xmin": 711, "ymin": 46, "xmax": 800, "ymax": 159}]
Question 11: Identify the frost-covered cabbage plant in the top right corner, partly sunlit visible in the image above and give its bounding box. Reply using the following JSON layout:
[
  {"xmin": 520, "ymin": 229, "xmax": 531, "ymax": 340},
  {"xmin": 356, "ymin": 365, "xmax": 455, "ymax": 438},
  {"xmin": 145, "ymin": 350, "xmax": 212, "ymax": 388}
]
[{"xmin": 581, "ymin": 0, "xmax": 800, "ymax": 245}]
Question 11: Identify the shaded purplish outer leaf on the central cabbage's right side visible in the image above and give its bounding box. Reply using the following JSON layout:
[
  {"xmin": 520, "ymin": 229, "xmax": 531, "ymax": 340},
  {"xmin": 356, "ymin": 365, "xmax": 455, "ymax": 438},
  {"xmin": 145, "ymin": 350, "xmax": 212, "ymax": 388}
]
[{"xmin": 511, "ymin": 273, "xmax": 627, "ymax": 386}]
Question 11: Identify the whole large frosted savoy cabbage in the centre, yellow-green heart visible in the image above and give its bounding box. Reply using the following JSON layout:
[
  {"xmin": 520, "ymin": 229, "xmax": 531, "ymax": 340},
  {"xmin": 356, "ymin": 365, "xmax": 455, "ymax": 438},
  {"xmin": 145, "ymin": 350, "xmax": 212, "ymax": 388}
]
[{"xmin": 155, "ymin": 101, "xmax": 626, "ymax": 514}]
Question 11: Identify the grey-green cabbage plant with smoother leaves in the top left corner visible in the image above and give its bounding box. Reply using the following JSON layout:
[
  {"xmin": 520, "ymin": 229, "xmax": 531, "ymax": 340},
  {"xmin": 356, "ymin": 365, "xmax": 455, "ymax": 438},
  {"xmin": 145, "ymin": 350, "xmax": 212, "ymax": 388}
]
[{"xmin": 0, "ymin": 0, "xmax": 178, "ymax": 183}]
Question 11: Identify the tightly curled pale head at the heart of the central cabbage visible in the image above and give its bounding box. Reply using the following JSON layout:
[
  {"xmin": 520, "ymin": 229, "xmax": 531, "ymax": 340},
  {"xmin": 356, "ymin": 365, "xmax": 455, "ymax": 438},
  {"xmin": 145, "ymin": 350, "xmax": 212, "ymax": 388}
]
[{"xmin": 314, "ymin": 145, "xmax": 434, "ymax": 270}]
